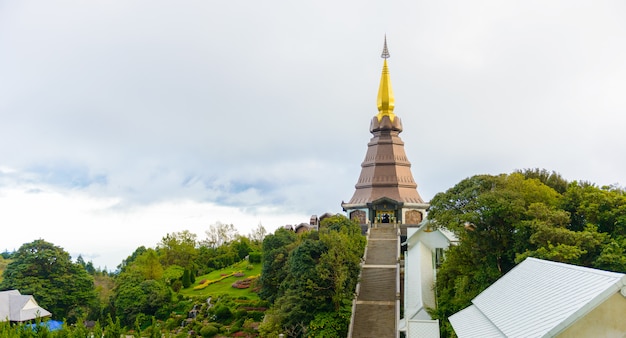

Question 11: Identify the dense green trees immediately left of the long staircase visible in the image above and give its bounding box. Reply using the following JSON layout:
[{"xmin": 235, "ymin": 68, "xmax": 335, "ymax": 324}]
[{"xmin": 259, "ymin": 216, "xmax": 365, "ymax": 337}]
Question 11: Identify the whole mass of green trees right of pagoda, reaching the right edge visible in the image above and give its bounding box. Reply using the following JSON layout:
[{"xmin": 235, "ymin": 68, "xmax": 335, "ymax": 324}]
[{"xmin": 429, "ymin": 173, "xmax": 626, "ymax": 337}]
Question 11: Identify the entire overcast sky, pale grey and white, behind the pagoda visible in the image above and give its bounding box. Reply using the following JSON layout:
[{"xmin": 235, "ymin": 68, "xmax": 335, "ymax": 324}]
[{"xmin": 0, "ymin": 0, "xmax": 626, "ymax": 270}]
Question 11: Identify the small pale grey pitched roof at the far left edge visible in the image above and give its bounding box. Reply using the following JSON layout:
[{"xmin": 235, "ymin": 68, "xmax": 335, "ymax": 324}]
[{"xmin": 0, "ymin": 290, "xmax": 52, "ymax": 322}]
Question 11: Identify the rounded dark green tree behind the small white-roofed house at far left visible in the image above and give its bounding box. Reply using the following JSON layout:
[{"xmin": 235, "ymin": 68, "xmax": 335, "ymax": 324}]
[{"xmin": 0, "ymin": 239, "xmax": 98, "ymax": 322}]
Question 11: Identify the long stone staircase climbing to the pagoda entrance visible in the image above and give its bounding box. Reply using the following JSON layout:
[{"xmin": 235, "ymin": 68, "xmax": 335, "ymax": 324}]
[{"xmin": 350, "ymin": 226, "xmax": 398, "ymax": 338}]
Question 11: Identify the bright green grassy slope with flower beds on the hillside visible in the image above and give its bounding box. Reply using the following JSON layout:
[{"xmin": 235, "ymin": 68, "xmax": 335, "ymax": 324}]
[{"xmin": 180, "ymin": 260, "xmax": 262, "ymax": 299}]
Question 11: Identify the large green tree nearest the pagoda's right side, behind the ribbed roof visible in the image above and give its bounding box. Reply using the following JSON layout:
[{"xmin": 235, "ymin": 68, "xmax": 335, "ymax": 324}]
[{"xmin": 429, "ymin": 173, "xmax": 567, "ymax": 336}]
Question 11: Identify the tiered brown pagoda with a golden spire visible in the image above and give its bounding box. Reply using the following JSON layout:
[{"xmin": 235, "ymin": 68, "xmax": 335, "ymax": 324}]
[{"xmin": 341, "ymin": 37, "xmax": 429, "ymax": 225}]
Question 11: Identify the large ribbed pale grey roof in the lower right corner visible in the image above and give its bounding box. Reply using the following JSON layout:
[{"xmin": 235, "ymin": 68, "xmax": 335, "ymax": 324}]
[{"xmin": 449, "ymin": 258, "xmax": 626, "ymax": 338}]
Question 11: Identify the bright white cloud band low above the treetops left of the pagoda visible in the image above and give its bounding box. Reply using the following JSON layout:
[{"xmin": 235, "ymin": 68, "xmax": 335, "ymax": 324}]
[{"xmin": 0, "ymin": 185, "xmax": 308, "ymax": 271}]
